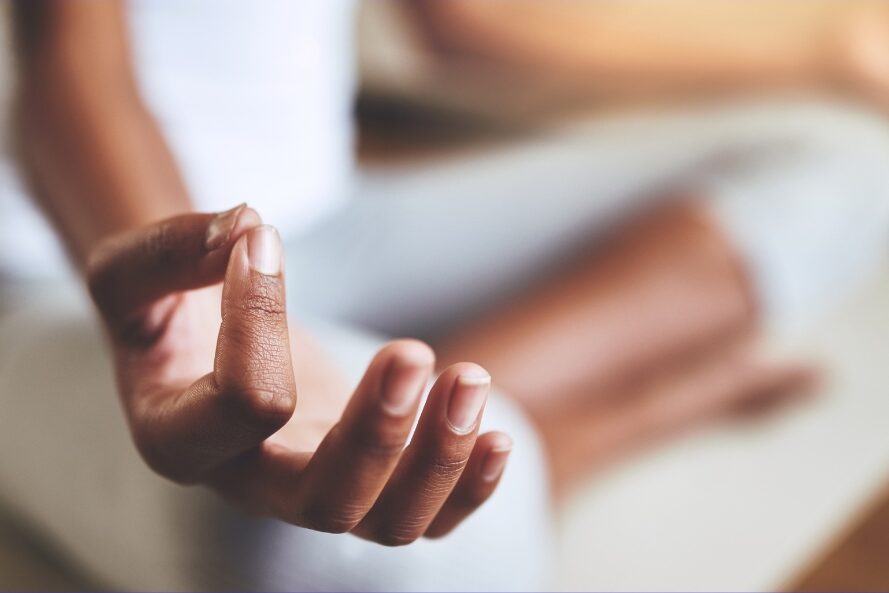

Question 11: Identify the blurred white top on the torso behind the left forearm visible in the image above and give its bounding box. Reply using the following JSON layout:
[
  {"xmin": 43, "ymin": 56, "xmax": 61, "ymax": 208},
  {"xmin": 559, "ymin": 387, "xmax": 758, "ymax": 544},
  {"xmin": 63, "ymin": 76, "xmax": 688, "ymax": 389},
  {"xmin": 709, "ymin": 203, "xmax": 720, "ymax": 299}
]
[{"xmin": 0, "ymin": 0, "xmax": 354, "ymax": 276}]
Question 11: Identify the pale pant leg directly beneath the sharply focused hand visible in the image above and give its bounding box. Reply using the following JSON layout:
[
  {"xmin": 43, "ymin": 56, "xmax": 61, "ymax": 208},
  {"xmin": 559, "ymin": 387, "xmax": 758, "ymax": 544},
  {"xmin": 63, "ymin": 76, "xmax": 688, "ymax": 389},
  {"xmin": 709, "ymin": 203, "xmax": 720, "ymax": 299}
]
[{"xmin": 0, "ymin": 285, "xmax": 550, "ymax": 591}]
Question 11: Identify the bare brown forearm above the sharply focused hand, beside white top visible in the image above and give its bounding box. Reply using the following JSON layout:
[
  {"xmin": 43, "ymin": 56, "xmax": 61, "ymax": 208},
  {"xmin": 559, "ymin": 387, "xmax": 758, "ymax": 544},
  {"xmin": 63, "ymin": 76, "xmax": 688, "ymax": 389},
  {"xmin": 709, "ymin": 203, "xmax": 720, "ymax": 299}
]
[{"xmin": 14, "ymin": 2, "xmax": 189, "ymax": 265}]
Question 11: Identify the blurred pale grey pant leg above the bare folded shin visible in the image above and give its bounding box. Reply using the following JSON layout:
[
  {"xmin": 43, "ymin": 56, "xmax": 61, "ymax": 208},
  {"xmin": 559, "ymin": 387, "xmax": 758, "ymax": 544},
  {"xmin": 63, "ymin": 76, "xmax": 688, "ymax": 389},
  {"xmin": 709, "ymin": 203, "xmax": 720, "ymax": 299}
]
[{"xmin": 288, "ymin": 102, "xmax": 889, "ymax": 335}]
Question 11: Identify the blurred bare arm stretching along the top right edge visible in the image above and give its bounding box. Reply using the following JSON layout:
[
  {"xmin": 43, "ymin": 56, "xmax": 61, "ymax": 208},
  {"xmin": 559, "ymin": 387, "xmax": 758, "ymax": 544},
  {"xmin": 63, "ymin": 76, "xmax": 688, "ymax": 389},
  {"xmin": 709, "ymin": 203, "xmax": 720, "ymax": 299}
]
[{"xmin": 404, "ymin": 0, "xmax": 889, "ymax": 100}]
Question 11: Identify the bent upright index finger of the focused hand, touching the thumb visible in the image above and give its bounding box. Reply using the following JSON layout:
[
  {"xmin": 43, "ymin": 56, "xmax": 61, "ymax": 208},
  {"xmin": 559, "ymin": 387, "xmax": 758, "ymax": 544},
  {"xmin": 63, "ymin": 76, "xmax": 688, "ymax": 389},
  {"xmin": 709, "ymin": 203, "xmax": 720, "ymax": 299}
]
[{"xmin": 128, "ymin": 225, "xmax": 296, "ymax": 482}]
